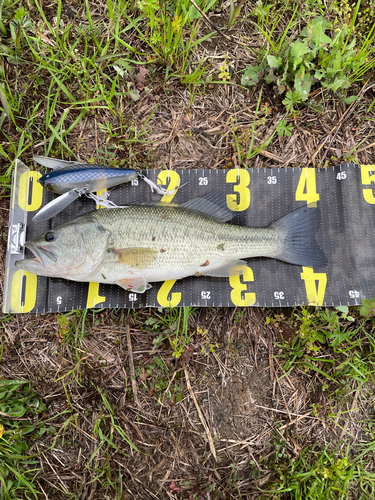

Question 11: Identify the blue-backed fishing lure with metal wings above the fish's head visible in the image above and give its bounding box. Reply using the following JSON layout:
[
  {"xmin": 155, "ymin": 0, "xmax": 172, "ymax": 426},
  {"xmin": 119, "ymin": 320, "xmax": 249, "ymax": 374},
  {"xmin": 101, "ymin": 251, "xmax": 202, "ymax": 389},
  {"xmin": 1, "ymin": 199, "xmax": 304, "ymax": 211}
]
[{"xmin": 33, "ymin": 156, "xmax": 176, "ymax": 222}]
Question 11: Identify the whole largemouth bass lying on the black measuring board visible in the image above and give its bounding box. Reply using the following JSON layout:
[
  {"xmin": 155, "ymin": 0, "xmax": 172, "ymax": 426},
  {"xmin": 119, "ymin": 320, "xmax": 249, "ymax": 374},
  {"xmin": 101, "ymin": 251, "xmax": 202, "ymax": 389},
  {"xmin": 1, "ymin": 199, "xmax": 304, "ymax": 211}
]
[{"xmin": 16, "ymin": 192, "xmax": 326, "ymax": 293}]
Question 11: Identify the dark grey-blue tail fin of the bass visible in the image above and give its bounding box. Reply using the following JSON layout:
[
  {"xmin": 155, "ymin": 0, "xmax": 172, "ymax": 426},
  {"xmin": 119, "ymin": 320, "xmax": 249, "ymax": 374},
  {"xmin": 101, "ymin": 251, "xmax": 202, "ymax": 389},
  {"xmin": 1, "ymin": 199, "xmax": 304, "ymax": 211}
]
[{"xmin": 271, "ymin": 206, "xmax": 327, "ymax": 268}]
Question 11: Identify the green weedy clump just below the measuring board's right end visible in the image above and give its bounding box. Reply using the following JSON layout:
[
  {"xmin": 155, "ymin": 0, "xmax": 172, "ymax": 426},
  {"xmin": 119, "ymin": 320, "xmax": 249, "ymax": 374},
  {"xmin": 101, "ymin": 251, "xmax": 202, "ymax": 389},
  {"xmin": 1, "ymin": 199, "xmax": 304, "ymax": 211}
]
[{"xmin": 274, "ymin": 308, "xmax": 375, "ymax": 399}]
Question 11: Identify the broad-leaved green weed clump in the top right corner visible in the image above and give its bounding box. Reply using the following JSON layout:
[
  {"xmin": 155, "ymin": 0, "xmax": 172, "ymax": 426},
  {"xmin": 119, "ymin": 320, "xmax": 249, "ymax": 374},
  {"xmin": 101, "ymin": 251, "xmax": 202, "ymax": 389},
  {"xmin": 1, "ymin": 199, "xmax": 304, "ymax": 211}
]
[{"xmin": 242, "ymin": 0, "xmax": 375, "ymax": 115}]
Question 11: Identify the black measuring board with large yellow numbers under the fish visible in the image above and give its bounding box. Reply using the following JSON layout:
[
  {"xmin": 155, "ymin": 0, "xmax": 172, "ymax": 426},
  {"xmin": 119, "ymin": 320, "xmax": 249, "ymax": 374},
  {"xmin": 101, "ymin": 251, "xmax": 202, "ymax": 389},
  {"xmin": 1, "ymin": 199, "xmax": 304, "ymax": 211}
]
[{"xmin": 3, "ymin": 162, "xmax": 375, "ymax": 312}]
